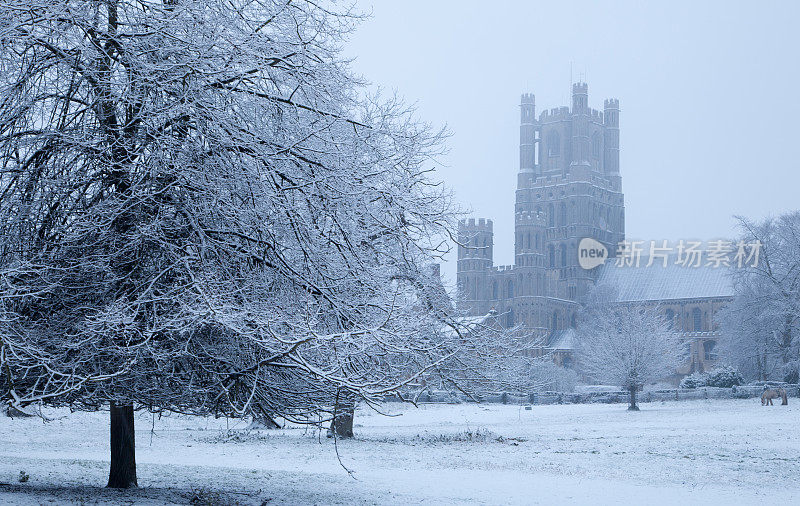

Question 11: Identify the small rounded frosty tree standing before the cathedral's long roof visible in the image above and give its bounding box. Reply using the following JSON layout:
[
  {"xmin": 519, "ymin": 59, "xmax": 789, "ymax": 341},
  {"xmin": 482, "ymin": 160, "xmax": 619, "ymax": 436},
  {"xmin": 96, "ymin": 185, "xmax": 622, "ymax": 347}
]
[{"xmin": 577, "ymin": 285, "xmax": 686, "ymax": 410}]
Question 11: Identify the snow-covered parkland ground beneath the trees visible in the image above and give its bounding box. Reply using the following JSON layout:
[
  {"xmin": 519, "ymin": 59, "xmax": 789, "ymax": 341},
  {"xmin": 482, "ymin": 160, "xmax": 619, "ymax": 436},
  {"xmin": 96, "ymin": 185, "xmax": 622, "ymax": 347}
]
[{"xmin": 0, "ymin": 399, "xmax": 800, "ymax": 505}]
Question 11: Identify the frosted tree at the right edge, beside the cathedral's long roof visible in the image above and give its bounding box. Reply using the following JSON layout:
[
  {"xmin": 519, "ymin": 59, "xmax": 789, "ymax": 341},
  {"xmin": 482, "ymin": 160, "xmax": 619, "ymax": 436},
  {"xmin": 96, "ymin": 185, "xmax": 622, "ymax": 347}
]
[{"xmin": 720, "ymin": 212, "xmax": 800, "ymax": 380}]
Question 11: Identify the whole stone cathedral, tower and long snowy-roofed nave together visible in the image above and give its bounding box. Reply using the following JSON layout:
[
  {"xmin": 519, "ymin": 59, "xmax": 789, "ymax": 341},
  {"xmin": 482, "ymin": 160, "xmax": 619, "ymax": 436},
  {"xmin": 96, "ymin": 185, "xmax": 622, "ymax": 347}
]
[{"xmin": 457, "ymin": 83, "xmax": 733, "ymax": 374}]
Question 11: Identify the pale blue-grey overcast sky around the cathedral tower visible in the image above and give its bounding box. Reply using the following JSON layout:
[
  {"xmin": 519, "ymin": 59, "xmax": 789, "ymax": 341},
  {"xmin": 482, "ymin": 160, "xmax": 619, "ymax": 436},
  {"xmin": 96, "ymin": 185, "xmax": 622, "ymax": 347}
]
[{"xmin": 346, "ymin": 0, "xmax": 800, "ymax": 281}]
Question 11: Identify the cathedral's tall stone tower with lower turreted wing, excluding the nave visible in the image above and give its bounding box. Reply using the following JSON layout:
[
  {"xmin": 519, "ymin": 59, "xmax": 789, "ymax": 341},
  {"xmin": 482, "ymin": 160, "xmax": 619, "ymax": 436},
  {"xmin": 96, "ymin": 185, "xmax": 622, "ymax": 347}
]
[{"xmin": 457, "ymin": 83, "xmax": 625, "ymax": 337}]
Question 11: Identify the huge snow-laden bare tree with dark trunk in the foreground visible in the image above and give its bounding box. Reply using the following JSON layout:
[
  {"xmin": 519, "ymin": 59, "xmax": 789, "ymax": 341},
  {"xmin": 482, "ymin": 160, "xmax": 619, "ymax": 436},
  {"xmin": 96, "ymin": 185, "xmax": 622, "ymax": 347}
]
[{"xmin": 0, "ymin": 0, "xmax": 528, "ymax": 487}]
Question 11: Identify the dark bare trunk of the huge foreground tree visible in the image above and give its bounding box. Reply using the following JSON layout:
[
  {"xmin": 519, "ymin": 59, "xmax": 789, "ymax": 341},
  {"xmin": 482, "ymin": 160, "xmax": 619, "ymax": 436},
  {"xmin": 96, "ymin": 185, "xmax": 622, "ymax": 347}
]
[{"xmin": 106, "ymin": 402, "xmax": 139, "ymax": 488}]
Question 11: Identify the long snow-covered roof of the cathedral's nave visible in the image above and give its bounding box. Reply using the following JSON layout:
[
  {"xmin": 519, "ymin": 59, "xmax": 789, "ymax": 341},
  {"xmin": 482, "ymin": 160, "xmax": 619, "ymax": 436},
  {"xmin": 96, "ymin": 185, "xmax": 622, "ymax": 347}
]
[{"xmin": 597, "ymin": 257, "xmax": 733, "ymax": 302}]
